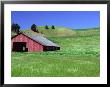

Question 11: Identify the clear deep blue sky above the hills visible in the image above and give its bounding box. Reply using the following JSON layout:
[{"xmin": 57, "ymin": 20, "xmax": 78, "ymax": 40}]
[{"xmin": 11, "ymin": 11, "xmax": 100, "ymax": 29}]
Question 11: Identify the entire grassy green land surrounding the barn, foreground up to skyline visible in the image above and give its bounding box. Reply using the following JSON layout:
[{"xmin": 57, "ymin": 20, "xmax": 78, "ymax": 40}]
[{"xmin": 11, "ymin": 27, "xmax": 100, "ymax": 77}]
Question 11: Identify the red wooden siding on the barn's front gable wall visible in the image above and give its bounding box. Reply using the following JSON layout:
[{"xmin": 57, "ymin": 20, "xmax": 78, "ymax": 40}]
[{"xmin": 11, "ymin": 34, "xmax": 43, "ymax": 52}]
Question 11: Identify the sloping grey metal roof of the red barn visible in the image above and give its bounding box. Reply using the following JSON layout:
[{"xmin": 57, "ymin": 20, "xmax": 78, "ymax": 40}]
[{"xmin": 22, "ymin": 33, "xmax": 60, "ymax": 47}]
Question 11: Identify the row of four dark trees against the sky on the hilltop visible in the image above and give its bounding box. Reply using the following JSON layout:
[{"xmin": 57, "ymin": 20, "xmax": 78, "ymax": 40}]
[{"xmin": 11, "ymin": 23, "xmax": 55, "ymax": 34}]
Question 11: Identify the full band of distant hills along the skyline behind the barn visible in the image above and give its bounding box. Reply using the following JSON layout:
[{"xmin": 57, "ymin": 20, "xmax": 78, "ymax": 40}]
[{"xmin": 12, "ymin": 26, "xmax": 100, "ymax": 37}]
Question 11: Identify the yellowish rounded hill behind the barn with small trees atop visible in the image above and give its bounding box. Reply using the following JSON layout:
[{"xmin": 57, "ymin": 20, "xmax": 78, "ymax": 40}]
[{"xmin": 23, "ymin": 26, "xmax": 76, "ymax": 37}]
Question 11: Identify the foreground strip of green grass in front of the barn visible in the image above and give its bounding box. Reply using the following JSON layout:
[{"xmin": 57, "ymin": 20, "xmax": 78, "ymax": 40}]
[{"xmin": 12, "ymin": 52, "xmax": 99, "ymax": 77}]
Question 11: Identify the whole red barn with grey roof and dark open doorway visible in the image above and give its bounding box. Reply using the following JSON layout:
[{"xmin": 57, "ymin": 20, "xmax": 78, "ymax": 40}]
[{"xmin": 11, "ymin": 33, "xmax": 60, "ymax": 52}]
